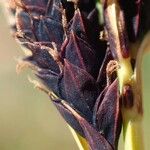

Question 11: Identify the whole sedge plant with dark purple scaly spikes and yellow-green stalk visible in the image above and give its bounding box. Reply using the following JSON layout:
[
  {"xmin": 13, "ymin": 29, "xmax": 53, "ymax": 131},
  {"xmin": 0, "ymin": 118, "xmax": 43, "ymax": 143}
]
[{"xmin": 3, "ymin": 0, "xmax": 150, "ymax": 150}]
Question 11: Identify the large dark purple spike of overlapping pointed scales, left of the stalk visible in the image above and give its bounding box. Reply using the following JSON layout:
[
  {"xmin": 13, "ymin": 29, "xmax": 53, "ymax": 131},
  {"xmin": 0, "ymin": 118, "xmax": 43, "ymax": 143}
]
[{"xmin": 7, "ymin": 0, "xmax": 121, "ymax": 150}]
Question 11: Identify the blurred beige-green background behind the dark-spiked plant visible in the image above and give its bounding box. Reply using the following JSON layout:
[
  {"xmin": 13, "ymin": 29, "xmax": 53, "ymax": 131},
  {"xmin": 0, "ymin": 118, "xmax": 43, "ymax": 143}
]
[{"xmin": 0, "ymin": 2, "xmax": 150, "ymax": 150}]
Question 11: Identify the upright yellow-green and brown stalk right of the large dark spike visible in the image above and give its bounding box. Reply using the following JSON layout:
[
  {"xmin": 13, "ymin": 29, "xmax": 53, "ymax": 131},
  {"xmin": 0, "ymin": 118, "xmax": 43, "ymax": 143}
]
[{"xmin": 96, "ymin": 0, "xmax": 144, "ymax": 150}]
